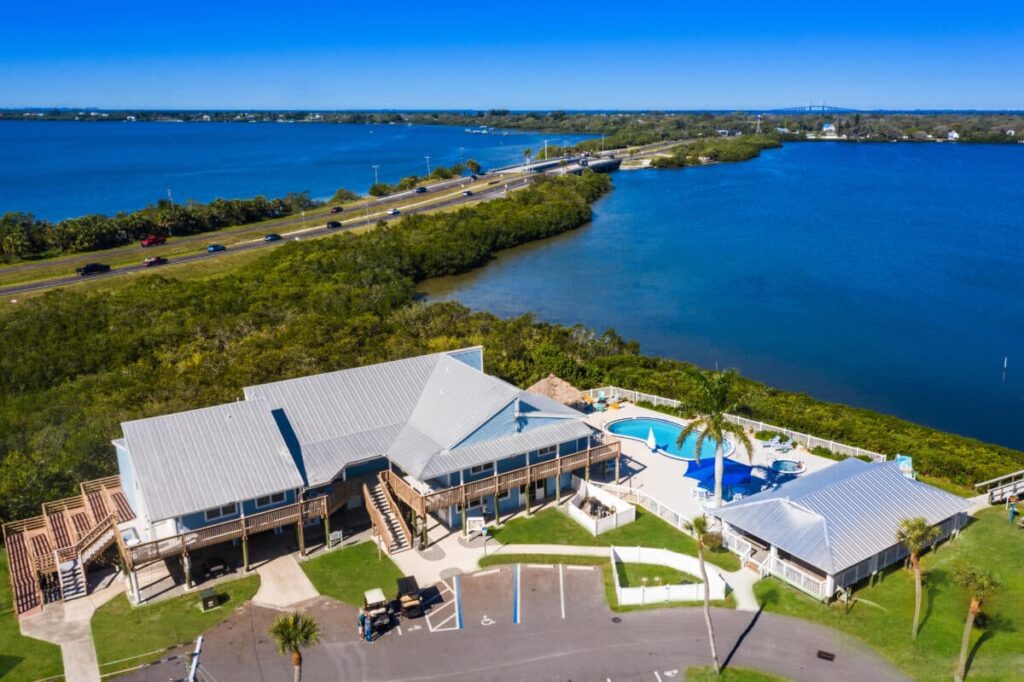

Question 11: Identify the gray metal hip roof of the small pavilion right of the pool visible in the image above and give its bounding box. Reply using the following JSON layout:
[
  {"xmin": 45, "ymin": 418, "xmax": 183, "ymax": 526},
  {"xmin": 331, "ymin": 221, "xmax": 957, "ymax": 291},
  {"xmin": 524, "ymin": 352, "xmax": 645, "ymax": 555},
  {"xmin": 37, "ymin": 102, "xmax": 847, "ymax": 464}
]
[{"xmin": 711, "ymin": 458, "xmax": 970, "ymax": 574}]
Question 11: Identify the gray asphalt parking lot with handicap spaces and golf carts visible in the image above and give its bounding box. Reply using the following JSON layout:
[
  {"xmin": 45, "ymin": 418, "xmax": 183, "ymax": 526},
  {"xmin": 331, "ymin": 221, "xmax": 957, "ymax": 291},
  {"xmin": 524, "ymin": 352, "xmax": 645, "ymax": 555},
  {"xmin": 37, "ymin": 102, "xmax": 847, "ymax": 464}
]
[{"xmin": 121, "ymin": 563, "xmax": 901, "ymax": 682}]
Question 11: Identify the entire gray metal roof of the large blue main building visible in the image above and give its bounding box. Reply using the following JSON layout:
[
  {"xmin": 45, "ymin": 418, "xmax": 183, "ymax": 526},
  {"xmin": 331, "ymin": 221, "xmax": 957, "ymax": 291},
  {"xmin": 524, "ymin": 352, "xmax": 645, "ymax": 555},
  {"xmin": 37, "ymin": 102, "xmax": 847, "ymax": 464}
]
[{"xmin": 122, "ymin": 353, "xmax": 592, "ymax": 520}]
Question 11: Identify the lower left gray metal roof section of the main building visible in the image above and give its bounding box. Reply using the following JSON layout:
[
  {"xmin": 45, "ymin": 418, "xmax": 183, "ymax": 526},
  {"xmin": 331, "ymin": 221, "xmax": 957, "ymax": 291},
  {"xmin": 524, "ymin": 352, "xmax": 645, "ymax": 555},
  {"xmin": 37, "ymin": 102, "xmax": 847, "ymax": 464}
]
[{"xmin": 121, "ymin": 400, "xmax": 302, "ymax": 521}]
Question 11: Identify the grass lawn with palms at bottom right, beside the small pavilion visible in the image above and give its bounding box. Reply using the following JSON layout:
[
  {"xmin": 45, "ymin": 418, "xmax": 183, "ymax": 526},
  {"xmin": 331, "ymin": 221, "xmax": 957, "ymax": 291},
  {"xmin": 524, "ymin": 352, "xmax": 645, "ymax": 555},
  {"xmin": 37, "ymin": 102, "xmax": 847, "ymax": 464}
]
[{"xmin": 755, "ymin": 508, "xmax": 1024, "ymax": 680}]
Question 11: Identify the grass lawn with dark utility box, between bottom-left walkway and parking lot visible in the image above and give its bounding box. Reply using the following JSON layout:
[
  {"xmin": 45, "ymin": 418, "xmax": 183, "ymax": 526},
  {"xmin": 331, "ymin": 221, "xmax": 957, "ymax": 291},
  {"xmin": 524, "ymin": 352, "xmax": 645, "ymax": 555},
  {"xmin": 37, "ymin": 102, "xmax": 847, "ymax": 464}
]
[{"xmin": 92, "ymin": 576, "xmax": 259, "ymax": 673}]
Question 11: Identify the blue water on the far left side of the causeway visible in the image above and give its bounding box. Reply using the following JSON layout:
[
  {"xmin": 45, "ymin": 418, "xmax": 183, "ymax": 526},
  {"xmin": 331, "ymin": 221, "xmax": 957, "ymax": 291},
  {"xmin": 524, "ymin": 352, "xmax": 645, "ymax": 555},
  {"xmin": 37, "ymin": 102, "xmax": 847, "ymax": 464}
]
[{"xmin": 0, "ymin": 121, "xmax": 588, "ymax": 220}]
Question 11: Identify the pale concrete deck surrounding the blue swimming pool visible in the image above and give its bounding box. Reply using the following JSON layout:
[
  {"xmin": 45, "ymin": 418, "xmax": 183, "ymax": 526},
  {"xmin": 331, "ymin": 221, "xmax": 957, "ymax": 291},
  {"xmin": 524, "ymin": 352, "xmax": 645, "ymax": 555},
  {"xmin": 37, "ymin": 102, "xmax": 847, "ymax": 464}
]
[{"xmin": 587, "ymin": 402, "xmax": 835, "ymax": 518}]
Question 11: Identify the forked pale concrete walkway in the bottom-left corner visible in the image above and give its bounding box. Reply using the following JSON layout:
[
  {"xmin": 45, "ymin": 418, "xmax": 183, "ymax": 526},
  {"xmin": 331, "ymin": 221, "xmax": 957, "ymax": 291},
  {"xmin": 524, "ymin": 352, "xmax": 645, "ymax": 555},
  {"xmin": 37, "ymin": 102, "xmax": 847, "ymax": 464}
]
[{"xmin": 20, "ymin": 579, "xmax": 124, "ymax": 682}]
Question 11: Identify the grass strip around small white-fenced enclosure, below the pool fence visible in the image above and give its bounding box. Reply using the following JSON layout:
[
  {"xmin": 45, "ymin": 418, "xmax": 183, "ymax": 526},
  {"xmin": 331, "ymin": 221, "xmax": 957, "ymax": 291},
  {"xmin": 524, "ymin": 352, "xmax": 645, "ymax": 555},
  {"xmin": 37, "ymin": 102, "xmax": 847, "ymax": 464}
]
[{"xmin": 483, "ymin": 507, "xmax": 739, "ymax": 570}]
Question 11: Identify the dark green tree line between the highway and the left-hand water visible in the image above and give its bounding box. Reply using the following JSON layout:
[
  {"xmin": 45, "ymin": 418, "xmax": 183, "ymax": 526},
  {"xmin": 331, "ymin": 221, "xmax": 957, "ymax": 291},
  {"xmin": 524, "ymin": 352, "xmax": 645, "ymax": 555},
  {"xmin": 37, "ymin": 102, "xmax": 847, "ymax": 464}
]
[{"xmin": 0, "ymin": 191, "xmax": 319, "ymax": 262}]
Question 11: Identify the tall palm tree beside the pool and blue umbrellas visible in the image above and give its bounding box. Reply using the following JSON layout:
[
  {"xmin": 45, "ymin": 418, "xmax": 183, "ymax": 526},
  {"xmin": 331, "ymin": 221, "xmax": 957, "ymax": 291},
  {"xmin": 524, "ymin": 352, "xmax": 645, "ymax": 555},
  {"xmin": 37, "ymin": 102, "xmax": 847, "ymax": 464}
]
[{"xmin": 676, "ymin": 370, "xmax": 754, "ymax": 508}]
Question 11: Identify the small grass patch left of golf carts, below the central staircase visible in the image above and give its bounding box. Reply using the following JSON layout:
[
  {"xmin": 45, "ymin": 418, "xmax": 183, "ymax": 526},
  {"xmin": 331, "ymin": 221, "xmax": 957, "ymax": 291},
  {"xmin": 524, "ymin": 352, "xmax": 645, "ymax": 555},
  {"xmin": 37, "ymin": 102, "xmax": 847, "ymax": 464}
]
[{"xmin": 302, "ymin": 542, "xmax": 402, "ymax": 606}]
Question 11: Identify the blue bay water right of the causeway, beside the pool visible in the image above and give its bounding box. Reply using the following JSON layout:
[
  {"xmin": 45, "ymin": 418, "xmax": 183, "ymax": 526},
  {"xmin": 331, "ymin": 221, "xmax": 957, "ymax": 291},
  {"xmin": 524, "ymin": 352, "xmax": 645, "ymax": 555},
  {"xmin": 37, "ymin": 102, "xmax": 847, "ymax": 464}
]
[{"xmin": 426, "ymin": 143, "xmax": 1024, "ymax": 449}]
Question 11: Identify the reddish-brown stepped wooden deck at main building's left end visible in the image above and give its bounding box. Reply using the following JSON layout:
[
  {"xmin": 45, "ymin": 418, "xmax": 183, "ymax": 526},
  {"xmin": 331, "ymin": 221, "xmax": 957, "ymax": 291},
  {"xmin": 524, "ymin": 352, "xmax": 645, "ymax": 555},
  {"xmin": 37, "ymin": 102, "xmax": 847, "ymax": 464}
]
[{"xmin": 3, "ymin": 476, "xmax": 135, "ymax": 615}]
